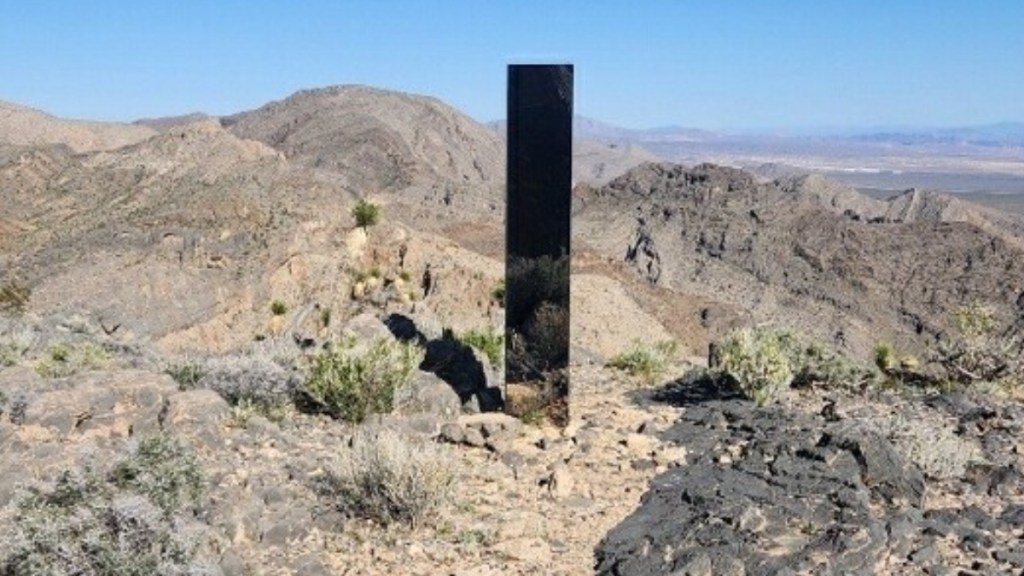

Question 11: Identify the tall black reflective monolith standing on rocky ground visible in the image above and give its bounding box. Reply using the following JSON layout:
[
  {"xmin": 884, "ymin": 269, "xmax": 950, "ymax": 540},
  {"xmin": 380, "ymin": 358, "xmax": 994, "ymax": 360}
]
[{"xmin": 505, "ymin": 65, "xmax": 572, "ymax": 425}]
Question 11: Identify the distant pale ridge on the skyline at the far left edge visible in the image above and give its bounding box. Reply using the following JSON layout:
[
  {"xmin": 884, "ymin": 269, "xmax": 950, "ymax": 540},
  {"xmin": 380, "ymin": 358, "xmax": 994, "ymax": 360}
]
[{"xmin": 0, "ymin": 101, "xmax": 156, "ymax": 152}]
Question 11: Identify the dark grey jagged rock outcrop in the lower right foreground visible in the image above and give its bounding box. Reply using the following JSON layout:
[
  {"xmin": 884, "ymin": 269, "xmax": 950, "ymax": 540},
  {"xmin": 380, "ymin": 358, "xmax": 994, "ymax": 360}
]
[{"xmin": 596, "ymin": 389, "xmax": 1022, "ymax": 576}]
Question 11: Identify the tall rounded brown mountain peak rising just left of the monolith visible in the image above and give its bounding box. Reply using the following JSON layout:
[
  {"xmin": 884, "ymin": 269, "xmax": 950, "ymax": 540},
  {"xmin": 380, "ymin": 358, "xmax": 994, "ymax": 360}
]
[{"xmin": 222, "ymin": 86, "xmax": 504, "ymax": 196}]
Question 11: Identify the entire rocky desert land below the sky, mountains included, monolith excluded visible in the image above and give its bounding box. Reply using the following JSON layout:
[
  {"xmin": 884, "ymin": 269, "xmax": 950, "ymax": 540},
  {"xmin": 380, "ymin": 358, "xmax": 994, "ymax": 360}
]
[{"xmin": 0, "ymin": 86, "xmax": 1024, "ymax": 576}]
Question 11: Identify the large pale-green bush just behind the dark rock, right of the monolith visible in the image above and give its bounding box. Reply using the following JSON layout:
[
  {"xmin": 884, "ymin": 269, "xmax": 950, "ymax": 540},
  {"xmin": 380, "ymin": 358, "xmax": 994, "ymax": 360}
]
[{"xmin": 712, "ymin": 328, "xmax": 874, "ymax": 406}]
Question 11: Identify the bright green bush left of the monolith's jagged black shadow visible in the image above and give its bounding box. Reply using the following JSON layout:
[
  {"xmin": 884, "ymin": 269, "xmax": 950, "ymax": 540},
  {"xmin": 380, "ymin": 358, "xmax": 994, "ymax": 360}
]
[{"xmin": 300, "ymin": 338, "xmax": 424, "ymax": 422}]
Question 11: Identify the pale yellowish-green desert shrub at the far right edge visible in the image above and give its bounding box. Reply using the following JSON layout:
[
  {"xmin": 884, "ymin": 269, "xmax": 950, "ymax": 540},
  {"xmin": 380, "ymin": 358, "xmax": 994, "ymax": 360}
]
[{"xmin": 934, "ymin": 303, "xmax": 1024, "ymax": 386}]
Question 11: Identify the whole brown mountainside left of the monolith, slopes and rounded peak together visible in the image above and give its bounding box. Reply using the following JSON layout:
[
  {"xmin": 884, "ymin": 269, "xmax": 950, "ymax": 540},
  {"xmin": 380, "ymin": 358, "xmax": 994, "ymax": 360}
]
[{"xmin": 0, "ymin": 87, "xmax": 512, "ymax": 349}]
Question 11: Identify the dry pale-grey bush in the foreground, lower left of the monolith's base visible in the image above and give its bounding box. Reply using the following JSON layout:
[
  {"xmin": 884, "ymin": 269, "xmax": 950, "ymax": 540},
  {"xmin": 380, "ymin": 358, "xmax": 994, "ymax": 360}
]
[{"xmin": 323, "ymin": 427, "xmax": 454, "ymax": 527}]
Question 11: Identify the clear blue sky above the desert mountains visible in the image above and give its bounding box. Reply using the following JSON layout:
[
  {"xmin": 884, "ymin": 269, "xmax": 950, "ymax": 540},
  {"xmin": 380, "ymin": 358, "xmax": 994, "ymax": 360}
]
[{"xmin": 0, "ymin": 0, "xmax": 1024, "ymax": 129}]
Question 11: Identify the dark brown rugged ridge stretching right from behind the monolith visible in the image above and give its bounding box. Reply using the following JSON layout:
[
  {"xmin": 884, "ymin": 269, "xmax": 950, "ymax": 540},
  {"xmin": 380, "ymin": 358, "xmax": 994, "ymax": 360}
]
[{"xmin": 574, "ymin": 164, "xmax": 1024, "ymax": 360}]
